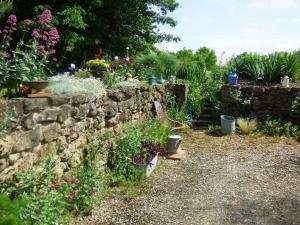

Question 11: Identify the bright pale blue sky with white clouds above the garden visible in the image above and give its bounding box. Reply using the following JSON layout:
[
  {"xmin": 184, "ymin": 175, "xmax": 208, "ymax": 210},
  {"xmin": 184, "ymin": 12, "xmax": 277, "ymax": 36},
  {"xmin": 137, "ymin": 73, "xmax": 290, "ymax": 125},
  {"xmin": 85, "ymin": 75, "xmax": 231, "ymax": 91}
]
[{"xmin": 157, "ymin": 0, "xmax": 300, "ymax": 56}]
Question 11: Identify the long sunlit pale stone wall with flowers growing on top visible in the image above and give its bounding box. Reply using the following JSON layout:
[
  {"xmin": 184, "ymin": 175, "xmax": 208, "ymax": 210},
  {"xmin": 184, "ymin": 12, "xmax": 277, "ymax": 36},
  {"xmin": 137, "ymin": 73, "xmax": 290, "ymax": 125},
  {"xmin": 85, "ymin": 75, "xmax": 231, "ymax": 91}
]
[{"xmin": 0, "ymin": 84, "xmax": 185, "ymax": 183}]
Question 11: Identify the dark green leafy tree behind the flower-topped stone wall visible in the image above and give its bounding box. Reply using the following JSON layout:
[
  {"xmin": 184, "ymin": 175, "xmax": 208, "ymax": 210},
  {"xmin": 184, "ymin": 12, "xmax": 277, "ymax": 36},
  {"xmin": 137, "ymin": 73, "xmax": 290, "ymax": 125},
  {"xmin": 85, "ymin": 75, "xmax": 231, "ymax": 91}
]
[{"xmin": 9, "ymin": 0, "xmax": 178, "ymax": 63}]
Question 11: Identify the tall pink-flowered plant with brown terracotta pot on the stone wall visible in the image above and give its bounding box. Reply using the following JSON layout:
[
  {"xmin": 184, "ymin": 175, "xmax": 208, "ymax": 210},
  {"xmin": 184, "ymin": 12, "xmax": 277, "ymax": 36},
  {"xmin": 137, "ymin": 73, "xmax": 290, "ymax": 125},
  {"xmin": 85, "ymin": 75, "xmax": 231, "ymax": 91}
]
[{"xmin": 0, "ymin": 10, "xmax": 59, "ymax": 96}]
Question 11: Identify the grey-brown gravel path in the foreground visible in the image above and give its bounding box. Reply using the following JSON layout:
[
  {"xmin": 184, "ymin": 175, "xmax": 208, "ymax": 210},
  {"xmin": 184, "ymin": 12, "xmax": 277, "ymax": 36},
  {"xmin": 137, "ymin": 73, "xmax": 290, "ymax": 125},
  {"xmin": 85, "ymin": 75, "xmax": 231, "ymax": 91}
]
[{"xmin": 72, "ymin": 131, "xmax": 300, "ymax": 225}]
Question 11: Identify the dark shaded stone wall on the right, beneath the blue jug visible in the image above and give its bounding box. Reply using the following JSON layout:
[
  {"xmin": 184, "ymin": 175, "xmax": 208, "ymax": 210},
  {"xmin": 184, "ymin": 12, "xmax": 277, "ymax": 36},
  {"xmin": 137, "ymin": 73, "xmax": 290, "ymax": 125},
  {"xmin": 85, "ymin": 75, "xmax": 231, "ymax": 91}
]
[{"xmin": 221, "ymin": 85, "xmax": 300, "ymax": 123}]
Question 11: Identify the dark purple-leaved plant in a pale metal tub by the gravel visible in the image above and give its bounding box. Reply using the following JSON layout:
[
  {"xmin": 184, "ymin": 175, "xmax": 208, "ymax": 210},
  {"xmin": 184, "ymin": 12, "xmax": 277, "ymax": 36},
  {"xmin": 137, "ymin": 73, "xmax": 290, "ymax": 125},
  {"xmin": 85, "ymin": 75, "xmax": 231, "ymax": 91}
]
[{"xmin": 132, "ymin": 141, "xmax": 166, "ymax": 177}]
